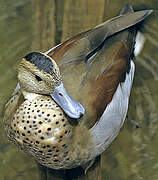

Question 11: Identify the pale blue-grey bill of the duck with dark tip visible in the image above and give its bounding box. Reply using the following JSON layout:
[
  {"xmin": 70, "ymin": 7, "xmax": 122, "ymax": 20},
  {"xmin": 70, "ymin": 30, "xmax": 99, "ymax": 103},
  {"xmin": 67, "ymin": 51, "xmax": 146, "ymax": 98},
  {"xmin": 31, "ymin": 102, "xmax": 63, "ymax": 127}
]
[{"xmin": 50, "ymin": 83, "xmax": 85, "ymax": 119}]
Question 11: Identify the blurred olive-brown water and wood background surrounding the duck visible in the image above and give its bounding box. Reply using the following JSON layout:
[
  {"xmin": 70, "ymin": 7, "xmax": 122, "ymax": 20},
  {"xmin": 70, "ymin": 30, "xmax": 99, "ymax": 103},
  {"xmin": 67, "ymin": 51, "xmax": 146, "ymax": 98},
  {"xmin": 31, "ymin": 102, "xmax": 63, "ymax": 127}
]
[{"xmin": 0, "ymin": 0, "xmax": 158, "ymax": 180}]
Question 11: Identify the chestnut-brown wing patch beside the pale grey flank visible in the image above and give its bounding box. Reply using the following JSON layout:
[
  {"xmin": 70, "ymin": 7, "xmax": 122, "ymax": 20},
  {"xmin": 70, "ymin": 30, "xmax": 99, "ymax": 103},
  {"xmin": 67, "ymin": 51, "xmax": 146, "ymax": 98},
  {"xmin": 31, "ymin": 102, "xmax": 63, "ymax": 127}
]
[{"xmin": 89, "ymin": 43, "xmax": 129, "ymax": 121}]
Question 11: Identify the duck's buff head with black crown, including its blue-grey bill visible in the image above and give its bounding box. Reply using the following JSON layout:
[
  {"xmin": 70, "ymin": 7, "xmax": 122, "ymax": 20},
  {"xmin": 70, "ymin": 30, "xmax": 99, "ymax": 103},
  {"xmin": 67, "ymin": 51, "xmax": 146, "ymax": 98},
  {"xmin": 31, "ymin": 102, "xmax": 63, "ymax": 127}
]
[{"xmin": 18, "ymin": 52, "xmax": 85, "ymax": 118}]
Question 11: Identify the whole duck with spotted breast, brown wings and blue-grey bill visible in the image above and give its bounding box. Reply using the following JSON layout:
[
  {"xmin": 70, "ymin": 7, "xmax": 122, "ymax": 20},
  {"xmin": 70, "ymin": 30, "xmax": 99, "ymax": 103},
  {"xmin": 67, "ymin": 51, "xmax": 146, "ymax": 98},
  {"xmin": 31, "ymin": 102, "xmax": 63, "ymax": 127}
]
[{"xmin": 4, "ymin": 5, "xmax": 152, "ymax": 169}]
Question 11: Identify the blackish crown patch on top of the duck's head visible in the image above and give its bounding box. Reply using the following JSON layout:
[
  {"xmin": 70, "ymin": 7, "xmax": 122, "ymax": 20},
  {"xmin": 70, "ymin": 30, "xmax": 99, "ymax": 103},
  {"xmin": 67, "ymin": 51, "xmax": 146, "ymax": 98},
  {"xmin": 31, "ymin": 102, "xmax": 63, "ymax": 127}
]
[{"xmin": 24, "ymin": 52, "xmax": 54, "ymax": 74}]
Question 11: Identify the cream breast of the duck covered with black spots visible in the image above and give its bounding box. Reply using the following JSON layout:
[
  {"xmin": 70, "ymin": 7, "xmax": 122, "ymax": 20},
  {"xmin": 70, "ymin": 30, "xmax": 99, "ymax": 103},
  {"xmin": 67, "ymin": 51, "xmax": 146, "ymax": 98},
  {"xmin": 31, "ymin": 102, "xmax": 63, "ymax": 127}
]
[{"xmin": 9, "ymin": 96, "xmax": 75, "ymax": 169}]
